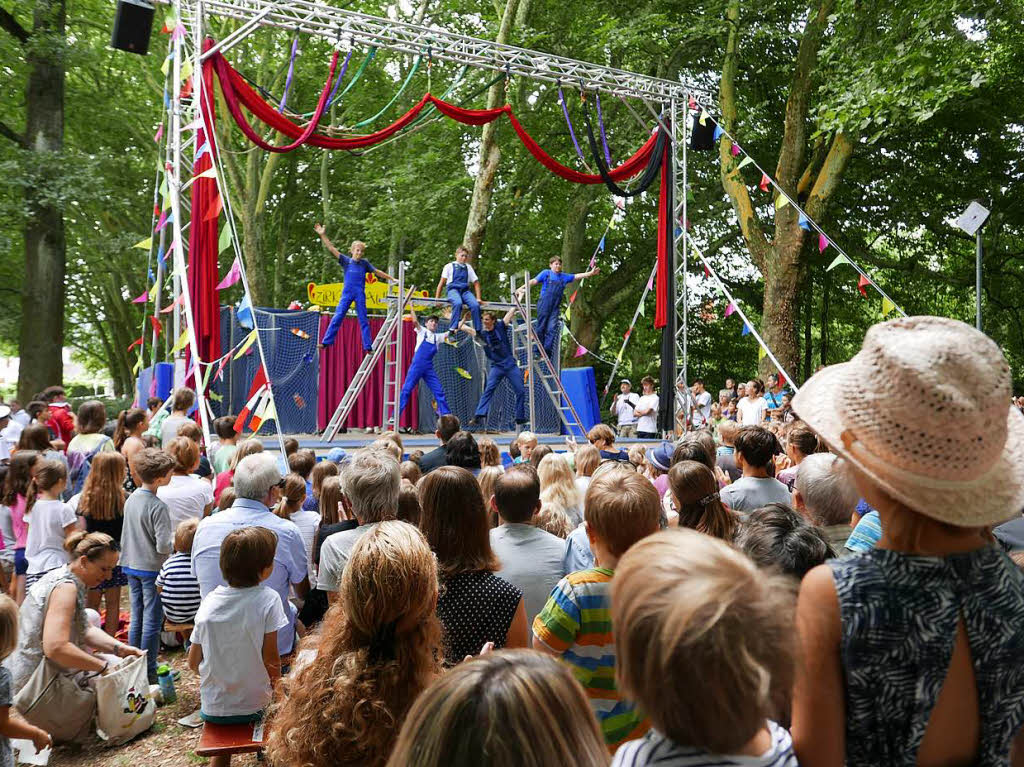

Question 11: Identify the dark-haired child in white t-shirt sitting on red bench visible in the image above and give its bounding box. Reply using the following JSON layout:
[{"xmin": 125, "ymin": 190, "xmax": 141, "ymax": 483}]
[{"xmin": 188, "ymin": 527, "xmax": 288, "ymax": 767}]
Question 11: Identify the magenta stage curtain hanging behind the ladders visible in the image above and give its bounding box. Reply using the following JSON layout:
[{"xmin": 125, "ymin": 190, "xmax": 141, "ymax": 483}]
[{"xmin": 316, "ymin": 314, "xmax": 420, "ymax": 430}]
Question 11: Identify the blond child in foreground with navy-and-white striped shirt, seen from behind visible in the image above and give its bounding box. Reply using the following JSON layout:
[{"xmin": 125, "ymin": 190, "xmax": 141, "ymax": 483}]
[{"xmin": 611, "ymin": 529, "xmax": 797, "ymax": 767}]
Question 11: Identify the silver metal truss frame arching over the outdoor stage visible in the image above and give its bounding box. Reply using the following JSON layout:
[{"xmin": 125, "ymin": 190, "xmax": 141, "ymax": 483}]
[{"xmin": 167, "ymin": 0, "xmax": 700, "ymax": 436}]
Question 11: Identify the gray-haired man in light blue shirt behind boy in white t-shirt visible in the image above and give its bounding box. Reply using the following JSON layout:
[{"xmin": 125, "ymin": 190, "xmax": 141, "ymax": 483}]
[{"xmin": 191, "ymin": 453, "xmax": 309, "ymax": 655}]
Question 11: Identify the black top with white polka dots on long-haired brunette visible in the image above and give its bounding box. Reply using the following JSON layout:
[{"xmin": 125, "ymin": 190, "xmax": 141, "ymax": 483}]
[{"xmin": 437, "ymin": 570, "xmax": 522, "ymax": 667}]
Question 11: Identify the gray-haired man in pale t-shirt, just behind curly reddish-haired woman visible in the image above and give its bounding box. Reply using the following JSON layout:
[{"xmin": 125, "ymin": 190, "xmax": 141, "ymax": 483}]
[{"xmin": 316, "ymin": 450, "xmax": 401, "ymax": 604}]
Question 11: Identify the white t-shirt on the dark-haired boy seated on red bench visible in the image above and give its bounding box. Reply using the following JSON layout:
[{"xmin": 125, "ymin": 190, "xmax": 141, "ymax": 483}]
[{"xmin": 191, "ymin": 586, "xmax": 288, "ymax": 717}]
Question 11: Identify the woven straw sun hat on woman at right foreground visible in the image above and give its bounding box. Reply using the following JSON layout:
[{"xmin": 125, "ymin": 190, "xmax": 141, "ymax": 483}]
[{"xmin": 793, "ymin": 316, "xmax": 1024, "ymax": 527}]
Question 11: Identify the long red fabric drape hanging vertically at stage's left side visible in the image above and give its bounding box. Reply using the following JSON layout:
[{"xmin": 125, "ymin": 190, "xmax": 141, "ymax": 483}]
[{"xmin": 188, "ymin": 52, "xmax": 220, "ymax": 368}]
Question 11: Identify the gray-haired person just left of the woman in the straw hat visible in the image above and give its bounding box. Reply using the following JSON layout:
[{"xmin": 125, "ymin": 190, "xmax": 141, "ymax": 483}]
[{"xmin": 793, "ymin": 453, "xmax": 859, "ymax": 554}]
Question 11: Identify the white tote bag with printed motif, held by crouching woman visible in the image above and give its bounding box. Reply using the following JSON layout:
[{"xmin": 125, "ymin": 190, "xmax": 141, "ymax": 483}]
[{"xmin": 95, "ymin": 655, "xmax": 157, "ymax": 745}]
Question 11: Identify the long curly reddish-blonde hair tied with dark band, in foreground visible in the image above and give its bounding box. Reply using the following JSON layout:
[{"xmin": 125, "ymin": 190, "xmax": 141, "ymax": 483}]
[{"xmin": 266, "ymin": 520, "xmax": 441, "ymax": 767}]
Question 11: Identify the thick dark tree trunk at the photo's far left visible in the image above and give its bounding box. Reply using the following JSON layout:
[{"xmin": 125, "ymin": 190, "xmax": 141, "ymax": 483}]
[{"xmin": 17, "ymin": 0, "xmax": 67, "ymax": 402}]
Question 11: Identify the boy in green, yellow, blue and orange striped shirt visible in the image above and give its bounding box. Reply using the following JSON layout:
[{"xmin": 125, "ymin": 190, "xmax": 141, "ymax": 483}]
[{"xmin": 534, "ymin": 469, "xmax": 660, "ymax": 753}]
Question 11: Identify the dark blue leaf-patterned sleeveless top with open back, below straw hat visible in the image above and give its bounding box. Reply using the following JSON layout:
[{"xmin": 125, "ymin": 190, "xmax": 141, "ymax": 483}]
[{"xmin": 828, "ymin": 547, "xmax": 1024, "ymax": 767}]
